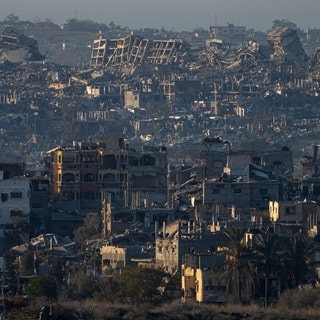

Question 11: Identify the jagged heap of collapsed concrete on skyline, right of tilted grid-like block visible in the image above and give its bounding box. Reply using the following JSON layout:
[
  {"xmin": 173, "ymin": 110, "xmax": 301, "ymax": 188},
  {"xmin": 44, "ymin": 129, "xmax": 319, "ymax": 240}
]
[{"xmin": 187, "ymin": 27, "xmax": 308, "ymax": 81}]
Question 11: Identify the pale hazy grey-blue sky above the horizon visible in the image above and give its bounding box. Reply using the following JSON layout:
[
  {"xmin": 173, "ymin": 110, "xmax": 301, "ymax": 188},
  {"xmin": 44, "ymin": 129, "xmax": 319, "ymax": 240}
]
[{"xmin": 0, "ymin": 0, "xmax": 320, "ymax": 31}]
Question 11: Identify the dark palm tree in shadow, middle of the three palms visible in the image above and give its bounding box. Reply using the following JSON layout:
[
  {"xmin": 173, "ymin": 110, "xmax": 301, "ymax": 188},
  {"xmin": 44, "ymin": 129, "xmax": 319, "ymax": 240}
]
[{"xmin": 253, "ymin": 232, "xmax": 282, "ymax": 306}]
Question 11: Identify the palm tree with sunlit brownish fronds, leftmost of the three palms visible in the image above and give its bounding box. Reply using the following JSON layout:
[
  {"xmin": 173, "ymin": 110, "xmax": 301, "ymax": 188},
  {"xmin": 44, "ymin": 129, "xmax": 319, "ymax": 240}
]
[{"xmin": 218, "ymin": 228, "xmax": 256, "ymax": 303}]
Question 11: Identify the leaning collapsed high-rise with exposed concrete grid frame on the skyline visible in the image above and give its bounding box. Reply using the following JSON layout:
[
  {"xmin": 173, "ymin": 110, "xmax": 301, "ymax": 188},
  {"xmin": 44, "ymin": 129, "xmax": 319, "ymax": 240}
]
[{"xmin": 91, "ymin": 35, "xmax": 187, "ymax": 66}]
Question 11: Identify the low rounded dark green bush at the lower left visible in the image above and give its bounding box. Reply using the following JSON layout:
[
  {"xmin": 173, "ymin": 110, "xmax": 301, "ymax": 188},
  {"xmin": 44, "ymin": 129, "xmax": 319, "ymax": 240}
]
[{"xmin": 26, "ymin": 276, "xmax": 58, "ymax": 301}]
